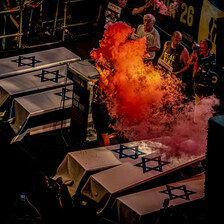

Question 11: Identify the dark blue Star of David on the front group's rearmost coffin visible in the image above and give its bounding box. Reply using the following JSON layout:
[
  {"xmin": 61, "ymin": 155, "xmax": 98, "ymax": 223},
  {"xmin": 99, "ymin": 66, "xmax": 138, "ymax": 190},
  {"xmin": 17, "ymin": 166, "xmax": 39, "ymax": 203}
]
[{"xmin": 111, "ymin": 145, "xmax": 145, "ymax": 159}]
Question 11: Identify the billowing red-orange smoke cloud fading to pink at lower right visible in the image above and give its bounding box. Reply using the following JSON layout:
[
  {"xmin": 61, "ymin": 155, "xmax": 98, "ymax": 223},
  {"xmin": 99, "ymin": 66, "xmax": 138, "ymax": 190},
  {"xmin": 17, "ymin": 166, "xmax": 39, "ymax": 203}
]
[{"xmin": 91, "ymin": 22, "xmax": 217, "ymax": 157}]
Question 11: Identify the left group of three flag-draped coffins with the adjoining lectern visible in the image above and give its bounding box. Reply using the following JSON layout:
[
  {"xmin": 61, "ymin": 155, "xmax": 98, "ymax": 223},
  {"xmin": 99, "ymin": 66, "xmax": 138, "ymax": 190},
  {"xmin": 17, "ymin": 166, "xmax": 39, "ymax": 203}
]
[{"xmin": 0, "ymin": 47, "xmax": 99, "ymax": 143}]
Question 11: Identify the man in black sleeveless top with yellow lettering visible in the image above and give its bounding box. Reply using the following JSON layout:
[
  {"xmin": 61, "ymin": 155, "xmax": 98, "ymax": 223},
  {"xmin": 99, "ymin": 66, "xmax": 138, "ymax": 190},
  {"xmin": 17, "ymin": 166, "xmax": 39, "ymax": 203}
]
[{"xmin": 158, "ymin": 31, "xmax": 189, "ymax": 80}]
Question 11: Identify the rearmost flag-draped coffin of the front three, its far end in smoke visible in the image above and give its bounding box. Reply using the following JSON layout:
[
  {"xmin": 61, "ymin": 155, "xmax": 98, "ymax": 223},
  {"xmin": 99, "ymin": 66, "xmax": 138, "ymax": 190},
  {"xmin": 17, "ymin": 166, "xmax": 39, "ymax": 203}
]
[{"xmin": 54, "ymin": 140, "xmax": 160, "ymax": 197}]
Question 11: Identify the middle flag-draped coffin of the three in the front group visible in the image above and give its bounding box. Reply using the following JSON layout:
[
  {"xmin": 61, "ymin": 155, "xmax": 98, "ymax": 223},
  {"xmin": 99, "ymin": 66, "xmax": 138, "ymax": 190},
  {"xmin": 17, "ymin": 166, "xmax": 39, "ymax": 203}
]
[{"xmin": 81, "ymin": 152, "xmax": 205, "ymax": 213}]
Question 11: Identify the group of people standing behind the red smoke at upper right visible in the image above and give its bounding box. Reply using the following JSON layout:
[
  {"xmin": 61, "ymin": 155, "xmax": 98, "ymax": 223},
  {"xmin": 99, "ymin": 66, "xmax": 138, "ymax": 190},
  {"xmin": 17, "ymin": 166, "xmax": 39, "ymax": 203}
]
[{"xmin": 93, "ymin": 0, "xmax": 219, "ymax": 100}]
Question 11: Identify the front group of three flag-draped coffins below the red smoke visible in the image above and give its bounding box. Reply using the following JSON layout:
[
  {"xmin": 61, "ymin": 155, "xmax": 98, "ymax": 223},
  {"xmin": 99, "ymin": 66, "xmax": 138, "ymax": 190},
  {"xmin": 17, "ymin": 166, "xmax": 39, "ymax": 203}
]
[{"xmin": 54, "ymin": 139, "xmax": 205, "ymax": 223}]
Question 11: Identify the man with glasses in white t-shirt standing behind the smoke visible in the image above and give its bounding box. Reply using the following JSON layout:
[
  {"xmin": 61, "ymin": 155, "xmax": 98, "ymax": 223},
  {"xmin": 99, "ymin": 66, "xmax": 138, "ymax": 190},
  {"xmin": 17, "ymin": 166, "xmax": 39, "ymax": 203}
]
[{"xmin": 133, "ymin": 14, "xmax": 161, "ymax": 61}]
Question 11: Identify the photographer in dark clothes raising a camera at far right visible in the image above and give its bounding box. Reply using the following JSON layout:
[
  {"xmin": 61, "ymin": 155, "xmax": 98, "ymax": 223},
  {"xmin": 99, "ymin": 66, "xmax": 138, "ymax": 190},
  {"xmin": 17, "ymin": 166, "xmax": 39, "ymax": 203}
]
[{"xmin": 188, "ymin": 39, "xmax": 218, "ymax": 99}]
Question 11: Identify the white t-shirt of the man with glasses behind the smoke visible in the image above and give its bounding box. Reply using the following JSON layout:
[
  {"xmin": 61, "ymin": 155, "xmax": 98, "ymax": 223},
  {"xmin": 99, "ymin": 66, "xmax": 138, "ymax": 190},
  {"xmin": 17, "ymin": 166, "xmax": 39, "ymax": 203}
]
[{"xmin": 136, "ymin": 24, "xmax": 161, "ymax": 59}]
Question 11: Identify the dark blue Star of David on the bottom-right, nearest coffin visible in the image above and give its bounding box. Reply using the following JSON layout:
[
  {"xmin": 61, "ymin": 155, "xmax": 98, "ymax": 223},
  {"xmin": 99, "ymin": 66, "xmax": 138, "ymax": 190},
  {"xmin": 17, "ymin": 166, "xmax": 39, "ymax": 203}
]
[{"xmin": 160, "ymin": 185, "xmax": 196, "ymax": 200}]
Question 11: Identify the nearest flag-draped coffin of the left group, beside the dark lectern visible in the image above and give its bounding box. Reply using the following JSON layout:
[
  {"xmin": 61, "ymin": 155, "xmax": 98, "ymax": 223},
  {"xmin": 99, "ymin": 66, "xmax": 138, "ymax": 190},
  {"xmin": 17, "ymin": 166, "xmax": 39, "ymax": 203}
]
[{"xmin": 10, "ymin": 84, "xmax": 73, "ymax": 143}]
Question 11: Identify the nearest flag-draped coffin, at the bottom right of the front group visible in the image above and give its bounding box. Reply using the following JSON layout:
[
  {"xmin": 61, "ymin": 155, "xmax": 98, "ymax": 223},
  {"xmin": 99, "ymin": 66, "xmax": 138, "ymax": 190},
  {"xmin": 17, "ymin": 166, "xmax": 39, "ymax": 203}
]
[{"xmin": 114, "ymin": 173, "xmax": 205, "ymax": 224}]
